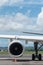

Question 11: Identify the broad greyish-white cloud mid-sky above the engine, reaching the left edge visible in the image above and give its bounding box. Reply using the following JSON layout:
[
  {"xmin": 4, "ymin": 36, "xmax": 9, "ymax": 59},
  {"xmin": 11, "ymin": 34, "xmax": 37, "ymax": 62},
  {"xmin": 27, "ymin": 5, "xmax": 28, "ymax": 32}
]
[{"xmin": 0, "ymin": 12, "xmax": 34, "ymax": 31}]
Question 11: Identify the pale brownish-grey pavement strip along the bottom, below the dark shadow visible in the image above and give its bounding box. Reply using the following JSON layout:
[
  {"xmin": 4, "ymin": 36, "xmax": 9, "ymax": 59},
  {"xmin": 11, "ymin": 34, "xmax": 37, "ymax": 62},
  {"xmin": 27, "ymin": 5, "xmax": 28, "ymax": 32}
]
[{"xmin": 0, "ymin": 60, "xmax": 43, "ymax": 65}]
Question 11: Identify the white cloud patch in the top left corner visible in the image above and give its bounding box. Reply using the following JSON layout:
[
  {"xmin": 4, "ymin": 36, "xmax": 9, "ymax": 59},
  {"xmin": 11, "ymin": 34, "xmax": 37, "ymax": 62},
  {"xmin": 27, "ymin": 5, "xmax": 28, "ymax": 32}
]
[{"xmin": 0, "ymin": 0, "xmax": 24, "ymax": 6}]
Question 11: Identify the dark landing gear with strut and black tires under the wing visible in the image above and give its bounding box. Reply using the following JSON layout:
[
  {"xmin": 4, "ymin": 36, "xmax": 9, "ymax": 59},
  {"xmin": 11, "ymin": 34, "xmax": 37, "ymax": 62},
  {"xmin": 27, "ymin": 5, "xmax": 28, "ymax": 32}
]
[{"xmin": 32, "ymin": 42, "xmax": 43, "ymax": 61}]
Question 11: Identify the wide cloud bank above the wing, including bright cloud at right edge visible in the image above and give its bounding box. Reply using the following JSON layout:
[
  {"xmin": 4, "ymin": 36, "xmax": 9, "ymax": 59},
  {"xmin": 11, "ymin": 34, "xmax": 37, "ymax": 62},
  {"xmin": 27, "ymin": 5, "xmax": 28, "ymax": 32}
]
[{"xmin": 0, "ymin": 7, "xmax": 43, "ymax": 32}]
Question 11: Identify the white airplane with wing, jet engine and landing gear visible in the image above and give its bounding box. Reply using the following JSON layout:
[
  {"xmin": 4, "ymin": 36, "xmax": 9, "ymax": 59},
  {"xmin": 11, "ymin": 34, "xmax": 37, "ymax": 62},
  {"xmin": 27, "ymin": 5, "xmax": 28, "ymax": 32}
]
[{"xmin": 0, "ymin": 32, "xmax": 43, "ymax": 61}]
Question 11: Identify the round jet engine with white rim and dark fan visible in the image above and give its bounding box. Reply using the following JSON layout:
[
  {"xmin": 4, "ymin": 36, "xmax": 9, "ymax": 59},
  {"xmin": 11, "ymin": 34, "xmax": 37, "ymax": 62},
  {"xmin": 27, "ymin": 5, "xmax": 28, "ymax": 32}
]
[{"xmin": 8, "ymin": 40, "xmax": 24, "ymax": 57}]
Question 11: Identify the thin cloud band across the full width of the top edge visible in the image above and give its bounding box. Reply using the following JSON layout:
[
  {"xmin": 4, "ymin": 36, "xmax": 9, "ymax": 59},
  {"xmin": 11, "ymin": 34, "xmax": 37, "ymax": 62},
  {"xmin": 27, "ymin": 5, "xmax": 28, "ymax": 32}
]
[{"xmin": 0, "ymin": 0, "xmax": 43, "ymax": 8}]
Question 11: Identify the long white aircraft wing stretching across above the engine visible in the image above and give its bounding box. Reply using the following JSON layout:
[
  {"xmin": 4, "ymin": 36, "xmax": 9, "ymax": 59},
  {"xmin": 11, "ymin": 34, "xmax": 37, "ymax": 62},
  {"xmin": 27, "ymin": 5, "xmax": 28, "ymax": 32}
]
[{"xmin": 0, "ymin": 35, "xmax": 43, "ymax": 42}]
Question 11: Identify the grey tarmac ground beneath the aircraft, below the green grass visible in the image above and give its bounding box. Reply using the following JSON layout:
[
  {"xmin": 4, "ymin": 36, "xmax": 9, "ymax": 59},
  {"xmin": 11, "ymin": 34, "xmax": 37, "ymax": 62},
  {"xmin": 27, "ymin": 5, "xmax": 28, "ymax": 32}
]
[{"xmin": 0, "ymin": 55, "xmax": 43, "ymax": 65}]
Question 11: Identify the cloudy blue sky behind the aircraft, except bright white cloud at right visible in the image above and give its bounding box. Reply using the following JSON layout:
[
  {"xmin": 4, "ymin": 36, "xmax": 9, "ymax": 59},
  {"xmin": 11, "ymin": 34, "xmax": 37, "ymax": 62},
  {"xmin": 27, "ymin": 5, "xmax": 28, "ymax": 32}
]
[{"xmin": 0, "ymin": 0, "xmax": 43, "ymax": 46}]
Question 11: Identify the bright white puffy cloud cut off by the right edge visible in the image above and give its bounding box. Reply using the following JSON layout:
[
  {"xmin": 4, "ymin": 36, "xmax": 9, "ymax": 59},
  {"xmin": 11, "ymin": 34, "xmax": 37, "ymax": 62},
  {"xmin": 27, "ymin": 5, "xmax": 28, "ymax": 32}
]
[{"xmin": 37, "ymin": 7, "xmax": 43, "ymax": 31}]
